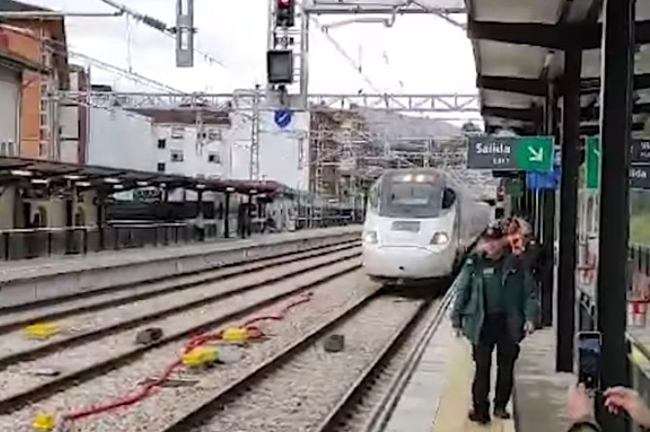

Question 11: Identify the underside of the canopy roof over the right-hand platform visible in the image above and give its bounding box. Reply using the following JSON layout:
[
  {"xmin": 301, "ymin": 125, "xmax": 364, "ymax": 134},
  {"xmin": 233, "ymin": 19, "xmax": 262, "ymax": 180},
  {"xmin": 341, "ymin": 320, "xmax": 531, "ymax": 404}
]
[{"xmin": 465, "ymin": 0, "xmax": 650, "ymax": 135}]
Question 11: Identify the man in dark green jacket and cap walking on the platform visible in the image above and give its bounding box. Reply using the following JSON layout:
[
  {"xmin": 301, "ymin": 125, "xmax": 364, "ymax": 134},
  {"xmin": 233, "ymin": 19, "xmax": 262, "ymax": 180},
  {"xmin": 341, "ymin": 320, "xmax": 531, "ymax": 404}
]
[{"xmin": 451, "ymin": 224, "xmax": 537, "ymax": 424}]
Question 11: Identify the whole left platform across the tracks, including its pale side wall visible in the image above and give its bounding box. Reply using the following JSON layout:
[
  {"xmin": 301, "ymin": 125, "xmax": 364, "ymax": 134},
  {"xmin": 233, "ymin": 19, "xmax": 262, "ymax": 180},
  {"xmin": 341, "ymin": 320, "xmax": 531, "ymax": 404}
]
[{"xmin": 0, "ymin": 225, "xmax": 361, "ymax": 309}]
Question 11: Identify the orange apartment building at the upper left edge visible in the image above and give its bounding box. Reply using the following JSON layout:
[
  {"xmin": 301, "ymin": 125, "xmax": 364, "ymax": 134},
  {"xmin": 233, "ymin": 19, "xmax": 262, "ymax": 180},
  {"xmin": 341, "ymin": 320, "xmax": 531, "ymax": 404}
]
[{"xmin": 0, "ymin": 0, "xmax": 69, "ymax": 160}]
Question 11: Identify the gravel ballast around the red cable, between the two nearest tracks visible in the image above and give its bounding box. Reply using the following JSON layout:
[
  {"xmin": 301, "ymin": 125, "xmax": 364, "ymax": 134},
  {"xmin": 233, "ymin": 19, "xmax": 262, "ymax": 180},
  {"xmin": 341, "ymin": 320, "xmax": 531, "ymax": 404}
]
[{"xmin": 0, "ymin": 263, "xmax": 376, "ymax": 432}]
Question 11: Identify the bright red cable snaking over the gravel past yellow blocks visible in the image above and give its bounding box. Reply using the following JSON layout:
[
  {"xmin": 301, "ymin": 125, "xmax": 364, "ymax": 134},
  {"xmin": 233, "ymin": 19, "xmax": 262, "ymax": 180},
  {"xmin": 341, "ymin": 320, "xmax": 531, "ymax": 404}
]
[{"xmin": 57, "ymin": 292, "xmax": 314, "ymax": 422}]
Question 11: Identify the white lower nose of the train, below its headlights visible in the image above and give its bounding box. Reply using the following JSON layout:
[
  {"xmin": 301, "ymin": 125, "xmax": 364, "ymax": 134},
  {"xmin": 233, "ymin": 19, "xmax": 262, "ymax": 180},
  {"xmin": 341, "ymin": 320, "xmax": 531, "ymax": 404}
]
[{"xmin": 363, "ymin": 246, "xmax": 455, "ymax": 279}]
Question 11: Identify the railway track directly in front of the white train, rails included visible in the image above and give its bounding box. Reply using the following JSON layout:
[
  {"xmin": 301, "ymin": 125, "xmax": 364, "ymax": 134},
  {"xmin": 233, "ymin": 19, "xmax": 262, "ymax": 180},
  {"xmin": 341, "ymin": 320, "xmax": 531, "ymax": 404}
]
[{"xmin": 154, "ymin": 286, "xmax": 449, "ymax": 432}]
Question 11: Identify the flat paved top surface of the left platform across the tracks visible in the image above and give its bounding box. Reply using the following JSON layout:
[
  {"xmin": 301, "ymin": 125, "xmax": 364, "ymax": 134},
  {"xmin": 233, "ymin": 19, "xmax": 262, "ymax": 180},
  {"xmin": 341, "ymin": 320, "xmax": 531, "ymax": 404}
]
[{"xmin": 0, "ymin": 225, "xmax": 361, "ymax": 282}]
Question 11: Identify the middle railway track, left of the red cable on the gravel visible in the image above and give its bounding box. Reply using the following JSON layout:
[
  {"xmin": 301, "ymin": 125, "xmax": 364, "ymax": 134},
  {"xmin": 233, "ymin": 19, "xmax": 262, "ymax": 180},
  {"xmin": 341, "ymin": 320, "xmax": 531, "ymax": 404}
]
[{"xmin": 0, "ymin": 245, "xmax": 359, "ymax": 414}]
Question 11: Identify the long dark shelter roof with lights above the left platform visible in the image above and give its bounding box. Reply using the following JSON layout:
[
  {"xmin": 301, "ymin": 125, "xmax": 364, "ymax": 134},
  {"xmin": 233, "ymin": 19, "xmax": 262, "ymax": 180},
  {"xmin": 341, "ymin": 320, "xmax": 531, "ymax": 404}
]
[{"xmin": 0, "ymin": 157, "xmax": 291, "ymax": 195}]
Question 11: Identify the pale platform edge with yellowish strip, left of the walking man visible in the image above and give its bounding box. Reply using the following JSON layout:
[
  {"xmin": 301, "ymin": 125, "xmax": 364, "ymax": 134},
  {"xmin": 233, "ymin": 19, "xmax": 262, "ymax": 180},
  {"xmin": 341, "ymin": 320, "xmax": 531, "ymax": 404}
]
[{"xmin": 384, "ymin": 317, "xmax": 516, "ymax": 432}]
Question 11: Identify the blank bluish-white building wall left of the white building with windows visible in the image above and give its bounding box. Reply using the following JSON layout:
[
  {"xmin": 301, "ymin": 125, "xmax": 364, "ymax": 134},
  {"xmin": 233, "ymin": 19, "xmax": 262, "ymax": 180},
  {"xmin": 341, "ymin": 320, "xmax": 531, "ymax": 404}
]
[{"xmin": 88, "ymin": 108, "xmax": 156, "ymax": 172}]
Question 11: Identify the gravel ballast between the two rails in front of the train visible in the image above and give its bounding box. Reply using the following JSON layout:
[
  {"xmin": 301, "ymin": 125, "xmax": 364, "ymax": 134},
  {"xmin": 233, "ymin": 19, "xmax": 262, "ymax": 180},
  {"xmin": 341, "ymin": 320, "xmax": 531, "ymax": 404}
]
[{"xmin": 195, "ymin": 296, "xmax": 421, "ymax": 432}]
